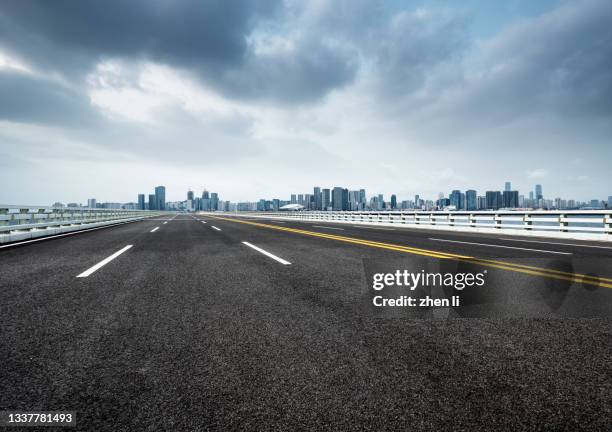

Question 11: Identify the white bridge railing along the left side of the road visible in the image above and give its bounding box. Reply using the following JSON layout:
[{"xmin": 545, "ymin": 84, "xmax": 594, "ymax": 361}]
[{"xmin": 0, "ymin": 205, "xmax": 166, "ymax": 244}]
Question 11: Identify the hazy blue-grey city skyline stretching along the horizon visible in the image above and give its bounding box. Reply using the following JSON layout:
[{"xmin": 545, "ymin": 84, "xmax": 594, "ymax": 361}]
[{"xmin": 54, "ymin": 182, "xmax": 612, "ymax": 212}]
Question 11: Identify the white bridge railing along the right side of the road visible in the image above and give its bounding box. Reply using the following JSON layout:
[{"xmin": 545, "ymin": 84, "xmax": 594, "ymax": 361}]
[{"xmin": 207, "ymin": 210, "xmax": 612, "ymax": 241}]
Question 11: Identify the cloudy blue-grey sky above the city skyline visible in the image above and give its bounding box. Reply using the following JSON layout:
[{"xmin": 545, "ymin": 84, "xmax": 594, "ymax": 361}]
[{"xmin": 0, "ymin": 0, "xmax": 612, "ymax": 204}]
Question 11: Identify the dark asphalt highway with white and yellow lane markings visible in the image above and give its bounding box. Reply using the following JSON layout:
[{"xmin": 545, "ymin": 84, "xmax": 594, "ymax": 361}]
[{"xmin": 0, "ymin": 214, "xmax": 612, "ymax": 431}]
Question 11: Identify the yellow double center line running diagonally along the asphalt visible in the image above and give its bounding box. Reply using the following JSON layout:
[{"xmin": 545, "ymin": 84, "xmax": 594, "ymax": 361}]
[{"xmin": 209, "ymin": 215, "xmax": 612, "ymax": 288}]
